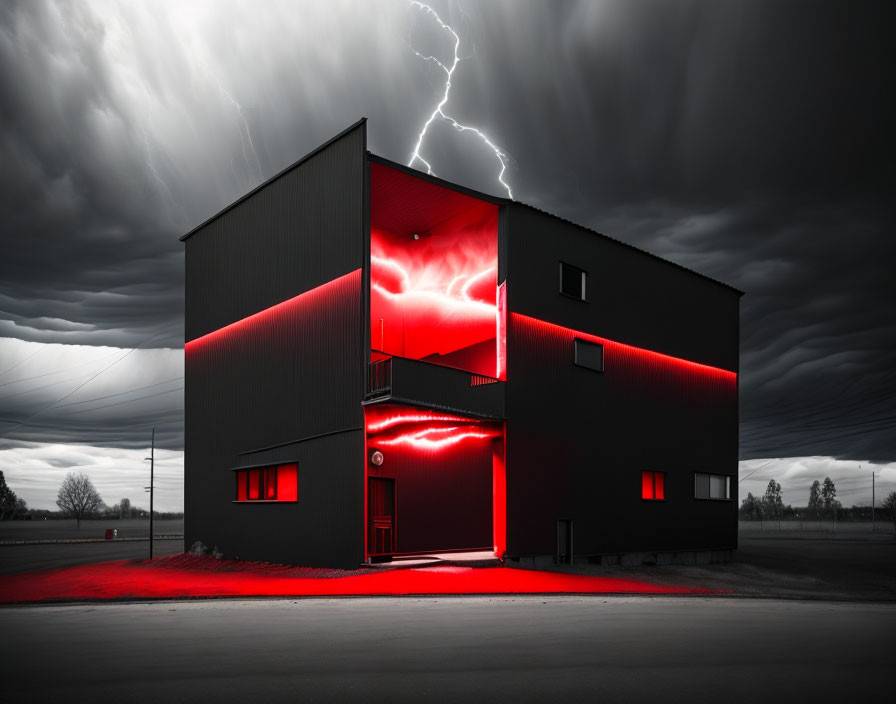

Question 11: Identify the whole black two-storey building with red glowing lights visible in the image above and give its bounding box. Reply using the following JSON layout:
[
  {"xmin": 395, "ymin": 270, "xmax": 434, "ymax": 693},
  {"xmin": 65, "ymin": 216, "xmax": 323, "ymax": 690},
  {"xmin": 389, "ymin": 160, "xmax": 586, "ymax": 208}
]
[{"xmin": 182, "ymin": 120, "xmax": 742, "ymax": 567}]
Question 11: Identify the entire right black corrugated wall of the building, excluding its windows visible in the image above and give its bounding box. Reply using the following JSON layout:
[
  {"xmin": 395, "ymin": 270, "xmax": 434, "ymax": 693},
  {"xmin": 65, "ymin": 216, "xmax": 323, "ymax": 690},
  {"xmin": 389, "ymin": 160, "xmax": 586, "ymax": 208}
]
[{"xmin": 505, "ymin": 206, "xmax": 739, "ymax": 556}]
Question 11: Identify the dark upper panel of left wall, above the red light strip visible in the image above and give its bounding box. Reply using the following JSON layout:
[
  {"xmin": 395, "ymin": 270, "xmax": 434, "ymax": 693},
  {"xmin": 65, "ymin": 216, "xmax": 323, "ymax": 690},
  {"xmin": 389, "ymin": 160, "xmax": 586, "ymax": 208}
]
[{"xmin": 185, "ymin": 123, "xmax": 366, "ymax": 340}]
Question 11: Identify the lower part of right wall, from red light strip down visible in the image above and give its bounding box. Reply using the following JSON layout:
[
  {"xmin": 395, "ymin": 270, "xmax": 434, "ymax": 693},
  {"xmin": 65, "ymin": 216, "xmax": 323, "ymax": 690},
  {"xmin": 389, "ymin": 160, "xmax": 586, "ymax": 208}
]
[{"xmin": 506, "ymin": 314, "xmax": 738, "ymax": 556}]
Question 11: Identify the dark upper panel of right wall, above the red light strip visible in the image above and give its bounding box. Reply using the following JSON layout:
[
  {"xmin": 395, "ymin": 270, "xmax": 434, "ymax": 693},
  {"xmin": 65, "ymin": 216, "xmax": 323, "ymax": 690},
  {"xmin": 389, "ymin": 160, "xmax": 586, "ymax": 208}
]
[{"xmin": 503, "ymin": 204, "xmax": 740, "ymax": 371}]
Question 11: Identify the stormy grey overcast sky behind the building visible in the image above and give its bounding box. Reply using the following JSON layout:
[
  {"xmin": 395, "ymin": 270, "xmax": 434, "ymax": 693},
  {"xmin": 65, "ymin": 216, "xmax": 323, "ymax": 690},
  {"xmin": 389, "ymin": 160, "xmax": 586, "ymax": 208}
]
[{"xmin": 0, "ymin": 0, "xmax": 896, "ymax": 508}]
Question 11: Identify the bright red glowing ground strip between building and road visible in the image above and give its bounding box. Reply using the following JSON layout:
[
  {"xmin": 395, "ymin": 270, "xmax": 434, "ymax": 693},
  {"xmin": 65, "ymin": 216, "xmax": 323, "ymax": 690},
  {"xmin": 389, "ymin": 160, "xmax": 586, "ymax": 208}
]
[{"xmin": 0, "ymin": 555, "xmax": 711, "ymax": 603}]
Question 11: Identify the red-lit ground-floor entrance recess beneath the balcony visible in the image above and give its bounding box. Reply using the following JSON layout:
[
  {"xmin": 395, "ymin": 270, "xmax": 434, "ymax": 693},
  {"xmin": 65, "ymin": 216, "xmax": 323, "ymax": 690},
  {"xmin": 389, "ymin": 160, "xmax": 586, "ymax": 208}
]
[{"xmin": 365, "ymin": 405, "xmax": 505, "ymax": 554}]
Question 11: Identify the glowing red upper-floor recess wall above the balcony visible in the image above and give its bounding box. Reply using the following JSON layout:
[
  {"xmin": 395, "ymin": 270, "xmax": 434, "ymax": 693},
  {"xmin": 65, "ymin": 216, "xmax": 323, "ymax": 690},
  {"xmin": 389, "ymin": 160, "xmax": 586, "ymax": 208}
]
[{"xmin": 370, "ymin": 164, "xmax": 503, "ymax": 378}]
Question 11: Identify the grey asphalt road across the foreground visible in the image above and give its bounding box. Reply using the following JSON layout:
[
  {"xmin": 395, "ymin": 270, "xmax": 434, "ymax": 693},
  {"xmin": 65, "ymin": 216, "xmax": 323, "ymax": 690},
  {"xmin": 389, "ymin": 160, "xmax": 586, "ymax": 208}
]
[{"xmin": 0, "ymin": 597, "xmax": 896, "ymax": 704}]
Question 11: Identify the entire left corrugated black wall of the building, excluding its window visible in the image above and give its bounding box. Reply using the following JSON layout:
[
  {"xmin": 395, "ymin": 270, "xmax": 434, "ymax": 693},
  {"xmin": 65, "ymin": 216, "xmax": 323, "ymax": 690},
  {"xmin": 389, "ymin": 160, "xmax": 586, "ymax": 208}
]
[{"xmin": 184, "ymin": 124, "xmax": 366, "ymax": 567}]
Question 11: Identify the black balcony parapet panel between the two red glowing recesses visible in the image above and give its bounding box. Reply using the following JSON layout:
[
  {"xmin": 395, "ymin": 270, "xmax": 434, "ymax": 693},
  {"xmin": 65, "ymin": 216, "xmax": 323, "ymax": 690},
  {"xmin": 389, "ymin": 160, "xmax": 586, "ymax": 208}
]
[{"xmin": 382, "ymin": 357, "xmax": 504, "ymax": 418}]
